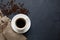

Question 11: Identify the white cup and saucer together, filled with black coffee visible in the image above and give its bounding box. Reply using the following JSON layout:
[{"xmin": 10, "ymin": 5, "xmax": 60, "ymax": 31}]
[{"xmin": 11, "ymin": 14, "xmax": 31, "ymax": 33}]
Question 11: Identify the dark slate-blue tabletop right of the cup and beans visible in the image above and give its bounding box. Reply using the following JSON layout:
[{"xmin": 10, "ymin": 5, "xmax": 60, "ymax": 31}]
[{"xmin": 1, "ymin": 0, "xmax": 60, "ymax": 40}]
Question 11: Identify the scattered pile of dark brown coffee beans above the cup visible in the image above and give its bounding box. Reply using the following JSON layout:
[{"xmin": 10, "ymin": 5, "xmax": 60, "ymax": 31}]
[{"xmin": 0, "ymin": 0, "xmax": 29, "ymax": 16}]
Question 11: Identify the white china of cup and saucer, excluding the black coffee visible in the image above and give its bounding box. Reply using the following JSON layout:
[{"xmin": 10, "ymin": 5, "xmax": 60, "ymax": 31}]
[{"xmin": 11, "ymin": 14, "xmax": 31, "ymax": 33}]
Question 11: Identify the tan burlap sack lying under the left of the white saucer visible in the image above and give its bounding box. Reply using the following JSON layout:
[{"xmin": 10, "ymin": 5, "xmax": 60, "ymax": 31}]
[{"xmin": 0, "ymin": 16, "xmax": 27, "ymax": 40}]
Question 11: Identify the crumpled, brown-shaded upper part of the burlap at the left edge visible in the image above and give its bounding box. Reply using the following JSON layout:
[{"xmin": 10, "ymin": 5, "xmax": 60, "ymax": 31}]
[{"xmin": 0, "ymin": 16, "xmax": 11, "ymax": 33}]
